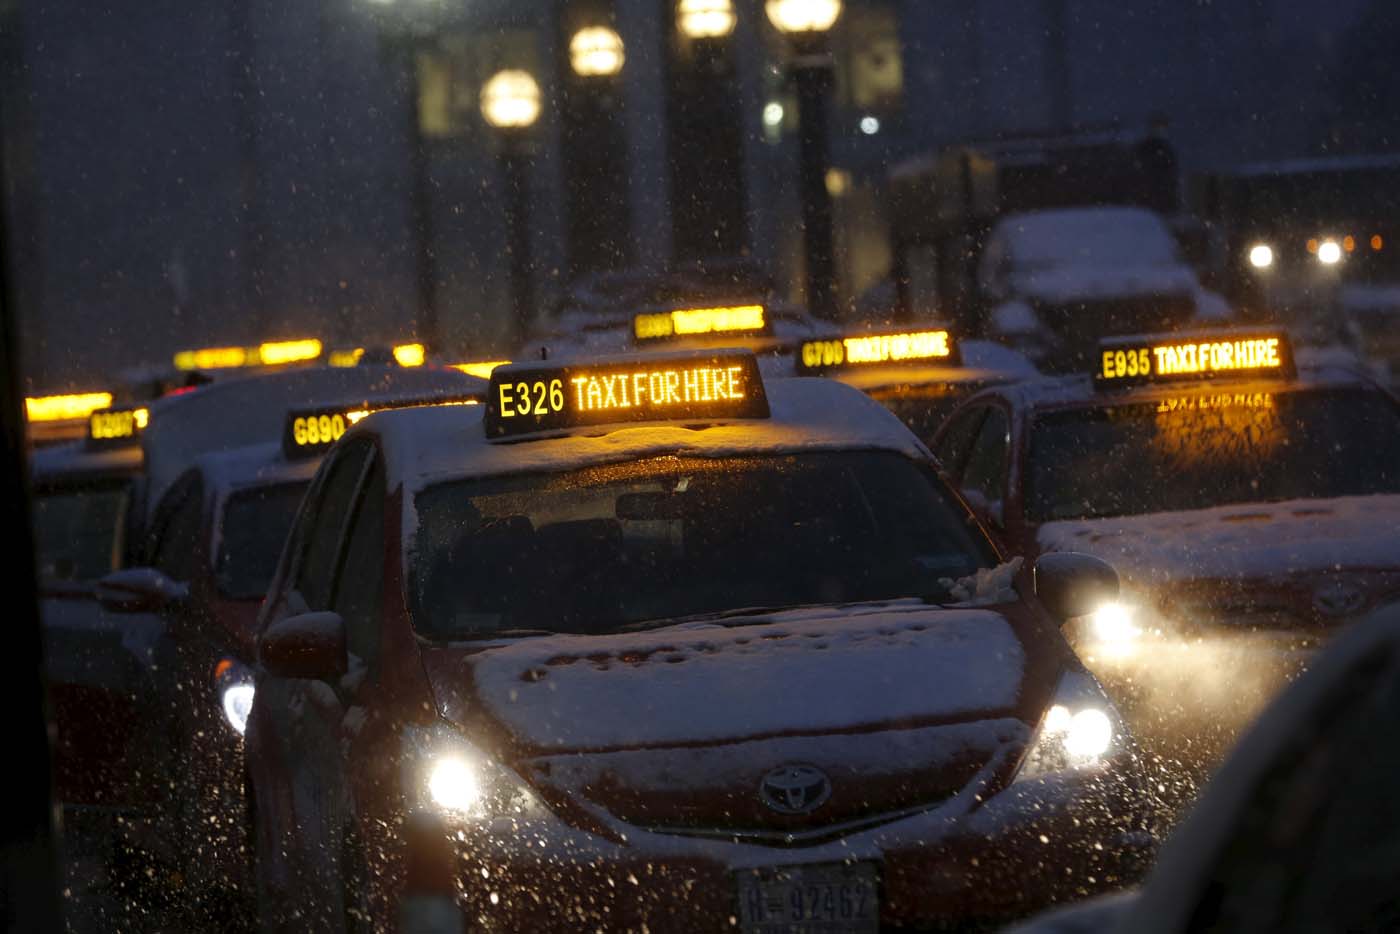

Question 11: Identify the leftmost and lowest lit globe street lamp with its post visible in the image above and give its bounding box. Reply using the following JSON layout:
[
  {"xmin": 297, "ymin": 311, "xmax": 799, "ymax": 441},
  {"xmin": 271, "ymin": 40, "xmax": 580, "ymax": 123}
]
[{"xmin": 482, "ymin": 69, "xmax": 540, "ymax": 347}]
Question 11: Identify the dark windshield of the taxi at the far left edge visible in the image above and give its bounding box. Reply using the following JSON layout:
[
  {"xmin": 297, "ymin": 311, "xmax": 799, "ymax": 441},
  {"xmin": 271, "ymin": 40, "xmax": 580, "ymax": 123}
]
[{"xmin": 34, "ymin": 480, "xmax": 130, "ymax": 583}]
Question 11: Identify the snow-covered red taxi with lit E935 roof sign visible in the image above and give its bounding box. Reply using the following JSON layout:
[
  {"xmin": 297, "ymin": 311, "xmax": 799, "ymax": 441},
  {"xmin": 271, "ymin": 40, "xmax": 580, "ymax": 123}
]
[{"xmin": 934, "ymin": 329, "xmax": 1400, "ymax": 773}]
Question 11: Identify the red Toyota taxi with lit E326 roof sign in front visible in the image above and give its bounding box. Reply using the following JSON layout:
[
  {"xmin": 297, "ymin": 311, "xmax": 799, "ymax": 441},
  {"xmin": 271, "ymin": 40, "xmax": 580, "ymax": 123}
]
[{"xmin": 246, "ymin": 350, "xmax": 1152, "ymax": 934}]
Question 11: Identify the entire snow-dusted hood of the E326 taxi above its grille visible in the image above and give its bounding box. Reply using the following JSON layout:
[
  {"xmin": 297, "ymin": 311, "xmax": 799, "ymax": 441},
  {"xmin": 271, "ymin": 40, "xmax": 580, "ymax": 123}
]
[{"xmin": 427, "ymin": 601, "xmax": 1061, "ymax": 839}]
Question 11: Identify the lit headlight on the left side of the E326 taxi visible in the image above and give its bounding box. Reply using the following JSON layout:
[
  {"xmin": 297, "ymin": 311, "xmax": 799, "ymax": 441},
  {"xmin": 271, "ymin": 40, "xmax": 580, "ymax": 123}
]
[{"xmin": 403, "ymin": 727, "xmax": 545, "ymax": 822}]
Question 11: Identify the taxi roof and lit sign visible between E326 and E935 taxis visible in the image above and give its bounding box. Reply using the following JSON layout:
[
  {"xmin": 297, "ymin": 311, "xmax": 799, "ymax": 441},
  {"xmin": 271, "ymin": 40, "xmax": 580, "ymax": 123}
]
[{"xmin": 792, "ymin": 323, "xmax": 1039, "ymax": 442}]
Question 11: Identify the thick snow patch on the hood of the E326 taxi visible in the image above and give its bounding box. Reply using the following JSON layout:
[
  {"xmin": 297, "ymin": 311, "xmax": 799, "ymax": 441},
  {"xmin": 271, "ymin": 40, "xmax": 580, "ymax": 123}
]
[{"xmin": 459, "ymin": 604, "xmax": 1025, "ymax": 751}]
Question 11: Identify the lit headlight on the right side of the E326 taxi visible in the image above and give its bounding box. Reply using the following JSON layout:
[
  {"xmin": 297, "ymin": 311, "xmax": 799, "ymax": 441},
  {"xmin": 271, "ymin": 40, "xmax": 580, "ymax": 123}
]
[{"xmin": 1016, "ymin": 671, "xmax": 1127, "ymax": 781}]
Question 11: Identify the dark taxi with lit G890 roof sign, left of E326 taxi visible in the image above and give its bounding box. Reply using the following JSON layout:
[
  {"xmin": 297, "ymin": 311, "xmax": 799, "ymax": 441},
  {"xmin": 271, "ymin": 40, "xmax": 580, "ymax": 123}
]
[{"xmin": 98, "ymin": 383, "xmax": 480, "ymax": 899}]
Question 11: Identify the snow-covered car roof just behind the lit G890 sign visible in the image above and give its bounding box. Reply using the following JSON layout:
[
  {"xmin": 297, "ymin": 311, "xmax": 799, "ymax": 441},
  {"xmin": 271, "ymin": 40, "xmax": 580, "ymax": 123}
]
[{"xmin": 141, "ymin": 365, "xmax": 487, "ymax": 518}]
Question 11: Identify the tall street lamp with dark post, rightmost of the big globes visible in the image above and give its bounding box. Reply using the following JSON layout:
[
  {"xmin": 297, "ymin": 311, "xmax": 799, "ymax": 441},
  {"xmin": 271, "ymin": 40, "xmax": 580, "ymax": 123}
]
[{"xmin": 764, "ymin": 0, "xmax": 841, "ymax": 318}]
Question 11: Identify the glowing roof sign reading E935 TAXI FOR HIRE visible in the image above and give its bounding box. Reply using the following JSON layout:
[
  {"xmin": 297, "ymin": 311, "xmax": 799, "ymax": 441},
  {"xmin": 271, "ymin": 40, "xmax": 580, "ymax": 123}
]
[{"xmin": 1093, "ymin": 330, "xmax": 1298, "ymax": 389}]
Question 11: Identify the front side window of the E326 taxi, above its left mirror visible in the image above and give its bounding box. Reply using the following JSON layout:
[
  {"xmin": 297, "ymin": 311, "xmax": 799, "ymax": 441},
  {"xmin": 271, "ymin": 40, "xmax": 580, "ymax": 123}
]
[{"xmin": 330, "ymin": 456, "xmax": 385, "ymax": 671}]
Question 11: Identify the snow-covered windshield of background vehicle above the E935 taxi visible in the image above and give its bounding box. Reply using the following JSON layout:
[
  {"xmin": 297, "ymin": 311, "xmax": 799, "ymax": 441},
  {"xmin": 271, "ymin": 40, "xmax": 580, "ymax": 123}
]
[{"xmin": 994, "ymin": 207, "xmax": 1179, "ymax": 270}]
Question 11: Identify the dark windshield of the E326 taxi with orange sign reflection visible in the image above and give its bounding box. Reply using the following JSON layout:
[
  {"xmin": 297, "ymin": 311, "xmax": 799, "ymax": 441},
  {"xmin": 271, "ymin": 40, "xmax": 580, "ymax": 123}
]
[{"xmin": 410, "ymin": 452, "xmax": 991, "ymax": 640}]
